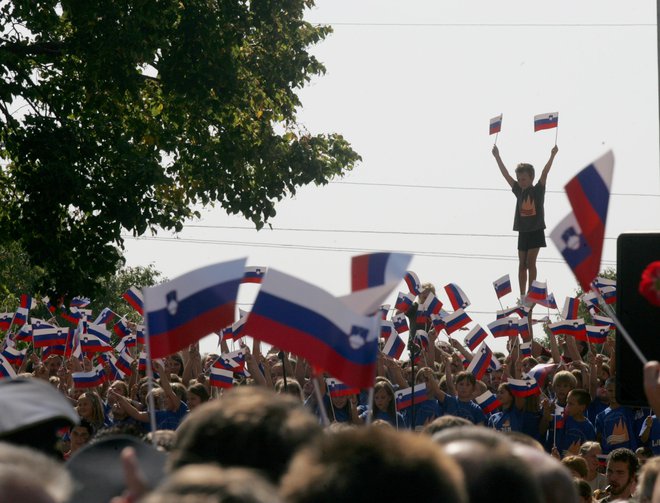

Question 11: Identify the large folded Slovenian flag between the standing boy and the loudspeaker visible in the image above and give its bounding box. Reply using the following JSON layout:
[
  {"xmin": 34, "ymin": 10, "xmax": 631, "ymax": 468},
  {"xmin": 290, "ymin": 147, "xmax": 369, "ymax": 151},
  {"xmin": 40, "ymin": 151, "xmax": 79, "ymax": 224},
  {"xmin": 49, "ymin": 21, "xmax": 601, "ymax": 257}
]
[{"xmin": 550, "ymin": 151, "xmax": 614, "ymax": 292}]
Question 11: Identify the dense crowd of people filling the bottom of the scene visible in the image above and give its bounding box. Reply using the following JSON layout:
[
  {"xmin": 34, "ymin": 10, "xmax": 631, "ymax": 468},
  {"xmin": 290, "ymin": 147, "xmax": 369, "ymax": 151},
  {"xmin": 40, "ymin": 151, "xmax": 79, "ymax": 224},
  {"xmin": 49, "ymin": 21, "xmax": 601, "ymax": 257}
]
[{"xmin": 0, "ymin": 284, "xmax": 660, "ymax": 503}]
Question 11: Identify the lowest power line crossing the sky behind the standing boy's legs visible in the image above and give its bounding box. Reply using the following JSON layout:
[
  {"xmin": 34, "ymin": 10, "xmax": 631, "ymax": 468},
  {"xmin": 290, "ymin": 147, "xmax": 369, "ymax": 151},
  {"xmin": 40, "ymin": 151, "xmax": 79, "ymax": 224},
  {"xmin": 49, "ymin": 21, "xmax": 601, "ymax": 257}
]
[{"xmin": 122, "ymin": 234, "xmax": 616, "ymax": 265}]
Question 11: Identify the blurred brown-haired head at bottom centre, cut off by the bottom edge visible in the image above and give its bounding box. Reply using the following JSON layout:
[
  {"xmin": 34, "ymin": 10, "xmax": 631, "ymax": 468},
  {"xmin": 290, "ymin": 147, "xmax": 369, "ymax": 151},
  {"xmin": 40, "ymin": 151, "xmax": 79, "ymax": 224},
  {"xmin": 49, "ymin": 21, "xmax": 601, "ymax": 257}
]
[{"xmin": 280, "ymin": 428, "xmax": 466, "ymax": 503}]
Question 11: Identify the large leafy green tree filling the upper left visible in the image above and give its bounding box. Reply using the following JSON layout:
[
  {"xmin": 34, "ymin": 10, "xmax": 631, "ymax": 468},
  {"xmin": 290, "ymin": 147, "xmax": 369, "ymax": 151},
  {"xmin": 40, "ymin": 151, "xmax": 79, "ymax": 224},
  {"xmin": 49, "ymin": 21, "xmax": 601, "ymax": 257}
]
[{"xmin": 0, "ymin": 0, "xmax": 360, "ymax": 296}]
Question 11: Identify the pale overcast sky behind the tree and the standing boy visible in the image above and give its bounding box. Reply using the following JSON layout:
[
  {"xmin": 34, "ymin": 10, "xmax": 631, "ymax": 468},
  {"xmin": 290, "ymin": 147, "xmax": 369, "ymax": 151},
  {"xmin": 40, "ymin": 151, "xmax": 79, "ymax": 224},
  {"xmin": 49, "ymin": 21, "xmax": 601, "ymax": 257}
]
[{"xmin": 127, "ymin": 0, "xmax": 660, "ymax": 351}]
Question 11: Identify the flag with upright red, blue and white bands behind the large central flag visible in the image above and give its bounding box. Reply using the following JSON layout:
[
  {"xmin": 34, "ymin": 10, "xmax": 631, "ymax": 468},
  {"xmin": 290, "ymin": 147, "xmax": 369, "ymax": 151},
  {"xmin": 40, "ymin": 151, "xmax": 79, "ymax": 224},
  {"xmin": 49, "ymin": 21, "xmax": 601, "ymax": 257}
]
[{"xmin": 351, "ymin": 252, "xmax": 410, "ymax": 295}]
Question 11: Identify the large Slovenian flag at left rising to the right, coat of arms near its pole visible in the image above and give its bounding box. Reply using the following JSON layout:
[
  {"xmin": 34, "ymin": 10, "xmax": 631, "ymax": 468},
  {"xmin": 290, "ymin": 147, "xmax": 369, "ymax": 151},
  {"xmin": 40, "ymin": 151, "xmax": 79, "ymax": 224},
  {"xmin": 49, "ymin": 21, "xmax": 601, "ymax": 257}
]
[{"xmin": 144, "ymin": 259, "xmax": 245, "ymax": 358}]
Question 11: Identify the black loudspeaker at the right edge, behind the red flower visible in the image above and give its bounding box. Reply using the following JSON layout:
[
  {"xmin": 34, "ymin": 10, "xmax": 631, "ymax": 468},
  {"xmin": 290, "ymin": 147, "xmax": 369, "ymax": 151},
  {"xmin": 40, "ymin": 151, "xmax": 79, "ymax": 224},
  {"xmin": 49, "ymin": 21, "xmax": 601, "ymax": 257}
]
[{"xmin": 616, "ymin": 232, "xmax": 660, "ymax": 407}]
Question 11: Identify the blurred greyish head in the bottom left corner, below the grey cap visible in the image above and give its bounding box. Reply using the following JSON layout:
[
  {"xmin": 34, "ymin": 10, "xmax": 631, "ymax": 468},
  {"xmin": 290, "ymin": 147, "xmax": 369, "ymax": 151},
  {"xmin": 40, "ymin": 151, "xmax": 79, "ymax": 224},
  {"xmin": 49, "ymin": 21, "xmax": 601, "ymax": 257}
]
[{"xmin": 0, "ymin": 442, "xmax": 73, "ymax": 503}]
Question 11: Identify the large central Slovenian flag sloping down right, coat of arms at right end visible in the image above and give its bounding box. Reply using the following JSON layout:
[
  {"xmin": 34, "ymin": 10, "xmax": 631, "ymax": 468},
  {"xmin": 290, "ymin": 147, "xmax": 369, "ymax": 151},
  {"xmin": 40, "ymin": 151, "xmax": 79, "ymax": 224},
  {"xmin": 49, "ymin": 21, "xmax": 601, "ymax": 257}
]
[{"xmin": 246, "ymin": 269, "xmax": 380, "ymax": 388}]
